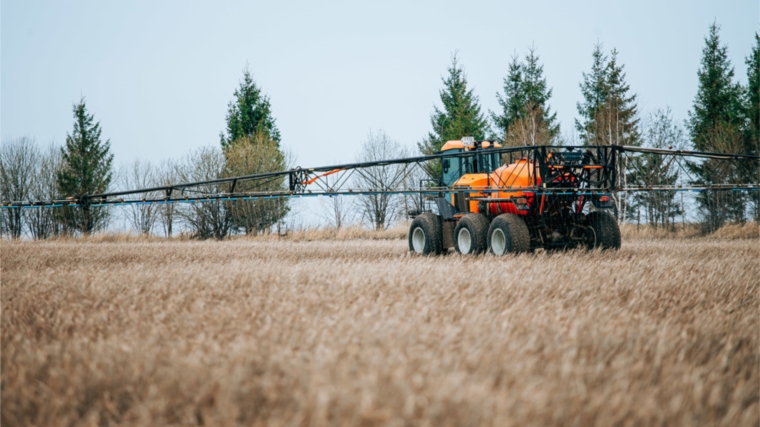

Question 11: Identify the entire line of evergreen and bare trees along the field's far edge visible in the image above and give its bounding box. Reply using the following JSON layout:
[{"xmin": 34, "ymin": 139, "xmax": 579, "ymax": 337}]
[{"xmin": 0, "ymin": 23, "xmax": 760, "ymax": 239}]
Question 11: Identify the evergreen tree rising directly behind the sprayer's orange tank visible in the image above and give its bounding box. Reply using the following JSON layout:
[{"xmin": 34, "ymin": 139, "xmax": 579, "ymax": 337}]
[{"xmin": 491, "ymin": 48, "xmax": 559, "ymax": 146}]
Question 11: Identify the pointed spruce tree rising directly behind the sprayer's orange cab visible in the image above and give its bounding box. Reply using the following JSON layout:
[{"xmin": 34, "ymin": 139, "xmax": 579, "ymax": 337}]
[{"xmin": 418, "ymin": 55, "xmax": 488, "ymax": 154}]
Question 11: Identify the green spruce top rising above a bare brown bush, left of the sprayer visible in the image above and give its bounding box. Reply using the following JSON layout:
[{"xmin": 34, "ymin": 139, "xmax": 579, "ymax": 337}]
[{"xmin": 219, "ymin": 67, "xmax": 280, "ymax": 147}]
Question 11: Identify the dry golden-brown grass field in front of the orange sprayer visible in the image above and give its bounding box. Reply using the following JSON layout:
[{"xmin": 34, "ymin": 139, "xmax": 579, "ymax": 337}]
[{"xmin": 1, "ymin": 233, "xmax": 760, "ymax": 426}]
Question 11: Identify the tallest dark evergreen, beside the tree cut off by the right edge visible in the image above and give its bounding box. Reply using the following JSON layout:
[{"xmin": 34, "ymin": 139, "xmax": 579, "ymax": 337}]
[{"xmin": 687, "ymin": 23, "xmax": 746, "ymax": 231}]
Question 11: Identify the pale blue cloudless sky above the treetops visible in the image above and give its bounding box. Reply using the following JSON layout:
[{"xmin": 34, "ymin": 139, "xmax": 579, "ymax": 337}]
[{"xmin": 0, "ymin": 0, "xmax": 760, "ymax": 170}]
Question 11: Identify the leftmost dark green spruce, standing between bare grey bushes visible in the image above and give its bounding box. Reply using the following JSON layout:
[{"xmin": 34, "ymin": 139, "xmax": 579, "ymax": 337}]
[{"xmin": 56, "ymin": 98, "xmax": 113, "ymax": 234}]
